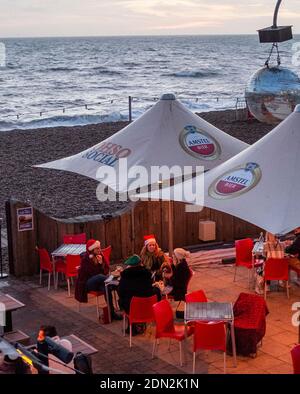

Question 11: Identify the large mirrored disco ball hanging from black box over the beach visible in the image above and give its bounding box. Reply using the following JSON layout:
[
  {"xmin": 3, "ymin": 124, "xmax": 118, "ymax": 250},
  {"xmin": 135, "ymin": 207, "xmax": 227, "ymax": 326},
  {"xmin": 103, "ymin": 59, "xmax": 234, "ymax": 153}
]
[{"xmin": 245, "ymin": 66, "xmax": 300, "ymax": 124}]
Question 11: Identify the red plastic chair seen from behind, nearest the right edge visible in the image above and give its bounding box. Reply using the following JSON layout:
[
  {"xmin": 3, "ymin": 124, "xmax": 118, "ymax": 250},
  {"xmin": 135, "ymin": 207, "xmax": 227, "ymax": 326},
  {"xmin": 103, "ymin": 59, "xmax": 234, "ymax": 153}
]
[{"xmin": 264, "ymin": 258, "xmax": 290, "ymax": 299}]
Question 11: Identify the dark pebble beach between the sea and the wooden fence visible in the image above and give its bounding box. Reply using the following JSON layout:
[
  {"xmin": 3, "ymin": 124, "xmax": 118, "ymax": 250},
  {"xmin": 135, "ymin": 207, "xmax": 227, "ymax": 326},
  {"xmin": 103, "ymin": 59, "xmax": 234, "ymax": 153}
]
[{"xmin": 0, "ymin": 110, "xmax": 274, "ymax": 222}]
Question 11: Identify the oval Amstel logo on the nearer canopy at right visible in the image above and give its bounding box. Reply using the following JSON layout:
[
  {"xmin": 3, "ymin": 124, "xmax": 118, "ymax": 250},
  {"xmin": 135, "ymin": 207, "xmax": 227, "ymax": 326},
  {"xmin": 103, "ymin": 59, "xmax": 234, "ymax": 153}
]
[{"xmin": 208, "ymin": 163, "xmax": 262, "ymax": 199}]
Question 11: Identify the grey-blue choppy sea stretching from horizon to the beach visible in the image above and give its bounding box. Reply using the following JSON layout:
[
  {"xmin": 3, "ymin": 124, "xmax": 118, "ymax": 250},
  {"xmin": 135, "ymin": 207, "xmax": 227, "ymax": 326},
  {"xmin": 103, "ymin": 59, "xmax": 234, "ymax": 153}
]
[{"xmin": 0, "ymin": 34, "xmax": 300, "ymax": 131}]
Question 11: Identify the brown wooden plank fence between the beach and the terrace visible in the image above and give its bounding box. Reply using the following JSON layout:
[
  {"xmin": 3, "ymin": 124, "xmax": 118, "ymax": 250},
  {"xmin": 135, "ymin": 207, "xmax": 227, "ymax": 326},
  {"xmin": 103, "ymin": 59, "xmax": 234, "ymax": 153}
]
[{"xmin": 6, "ymin": 200, "xmax": 261, "ymax": 276}]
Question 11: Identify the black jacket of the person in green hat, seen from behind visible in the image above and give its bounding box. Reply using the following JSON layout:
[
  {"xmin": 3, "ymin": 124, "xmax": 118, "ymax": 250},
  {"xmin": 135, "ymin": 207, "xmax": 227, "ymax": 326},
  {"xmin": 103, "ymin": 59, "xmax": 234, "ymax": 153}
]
[{"xmin": 118, "ymin": 265, "xmax": 154, "ymax": 313}]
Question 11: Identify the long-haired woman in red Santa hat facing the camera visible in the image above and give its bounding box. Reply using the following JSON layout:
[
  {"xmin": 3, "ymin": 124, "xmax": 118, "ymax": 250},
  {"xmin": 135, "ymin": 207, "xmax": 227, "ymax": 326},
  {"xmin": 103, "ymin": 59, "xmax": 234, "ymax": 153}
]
[{"xmin": 140, "ymin": 234, "xmax": 168, "ymax": 281}]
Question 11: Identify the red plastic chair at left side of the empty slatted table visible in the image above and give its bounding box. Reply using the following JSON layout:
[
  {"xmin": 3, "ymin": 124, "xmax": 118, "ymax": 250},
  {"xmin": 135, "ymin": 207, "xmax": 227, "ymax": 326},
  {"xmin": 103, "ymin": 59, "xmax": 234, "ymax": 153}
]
[{"xmin": 152, "ymin": 300, "xmax": 192, "ymax": 366}]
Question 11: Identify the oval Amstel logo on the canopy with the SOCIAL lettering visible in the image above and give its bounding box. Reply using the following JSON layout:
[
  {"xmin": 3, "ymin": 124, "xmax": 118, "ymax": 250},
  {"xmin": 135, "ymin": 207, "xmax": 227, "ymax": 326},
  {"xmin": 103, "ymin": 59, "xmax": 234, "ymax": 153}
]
[{"xmin": 179, "ymin": 126, "xmax": 221, "ymax": 160}]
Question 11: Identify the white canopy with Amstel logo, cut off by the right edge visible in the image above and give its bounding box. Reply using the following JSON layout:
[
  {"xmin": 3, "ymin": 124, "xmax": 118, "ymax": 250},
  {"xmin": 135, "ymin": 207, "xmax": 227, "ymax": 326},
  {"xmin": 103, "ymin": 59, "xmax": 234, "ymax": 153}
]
[{"xmin": 139, "ymin": 105, "xmax": 300, "ymax": 234}]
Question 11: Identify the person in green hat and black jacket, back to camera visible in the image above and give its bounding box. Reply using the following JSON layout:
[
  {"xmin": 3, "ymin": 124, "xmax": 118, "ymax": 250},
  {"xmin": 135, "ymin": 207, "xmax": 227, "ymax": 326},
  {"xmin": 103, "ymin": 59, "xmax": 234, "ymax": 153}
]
[{"xmin": 118, "ymin": 254, "xmax": 161, "ymax": 335}]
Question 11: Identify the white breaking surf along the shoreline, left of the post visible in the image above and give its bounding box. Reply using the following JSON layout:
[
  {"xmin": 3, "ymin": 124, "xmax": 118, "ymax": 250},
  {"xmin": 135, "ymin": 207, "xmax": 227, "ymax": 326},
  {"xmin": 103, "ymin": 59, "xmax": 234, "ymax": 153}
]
[{"xmin": 0, "ymin": 111, "xmax": 128, "ymax": 131}]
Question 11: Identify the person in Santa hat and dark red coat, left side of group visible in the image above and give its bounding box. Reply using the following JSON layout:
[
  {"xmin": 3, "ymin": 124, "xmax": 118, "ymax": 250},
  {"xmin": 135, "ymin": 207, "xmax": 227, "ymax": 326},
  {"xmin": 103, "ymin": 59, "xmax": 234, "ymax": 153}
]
[{"xmin": 75, "ymin": 239, "xmax": 122, "ymax": 320}]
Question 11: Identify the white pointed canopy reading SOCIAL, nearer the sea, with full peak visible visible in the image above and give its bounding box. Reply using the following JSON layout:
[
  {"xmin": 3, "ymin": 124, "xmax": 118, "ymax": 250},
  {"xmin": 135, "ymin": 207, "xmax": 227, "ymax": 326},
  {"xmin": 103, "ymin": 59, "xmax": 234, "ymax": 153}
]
[{"xmin": 36, "ymin": 95, "xmax": 248, "ymax": 192}]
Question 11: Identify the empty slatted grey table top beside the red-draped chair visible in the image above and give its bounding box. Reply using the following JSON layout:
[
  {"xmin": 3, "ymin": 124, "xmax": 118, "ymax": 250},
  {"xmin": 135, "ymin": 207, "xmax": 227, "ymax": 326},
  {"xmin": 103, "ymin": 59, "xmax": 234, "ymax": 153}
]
[{"xmin": 184, "ymin": 302, "xmax": 233, "ymax": 321}]
